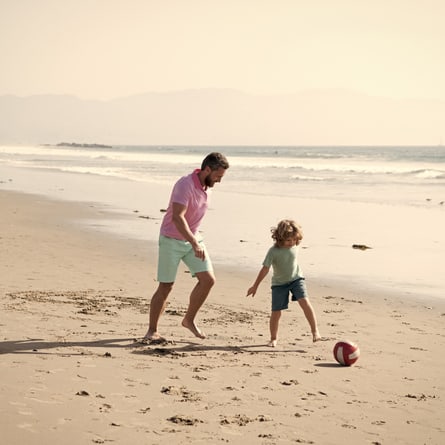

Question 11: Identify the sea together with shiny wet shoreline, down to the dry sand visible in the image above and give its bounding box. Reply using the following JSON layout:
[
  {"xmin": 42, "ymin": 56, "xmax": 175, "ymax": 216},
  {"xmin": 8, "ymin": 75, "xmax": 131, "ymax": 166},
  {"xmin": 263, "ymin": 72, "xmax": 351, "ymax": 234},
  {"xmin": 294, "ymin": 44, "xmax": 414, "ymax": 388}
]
[{"xmin": 0, "ymin": 146, "xmax": 445, "ymax": 298}]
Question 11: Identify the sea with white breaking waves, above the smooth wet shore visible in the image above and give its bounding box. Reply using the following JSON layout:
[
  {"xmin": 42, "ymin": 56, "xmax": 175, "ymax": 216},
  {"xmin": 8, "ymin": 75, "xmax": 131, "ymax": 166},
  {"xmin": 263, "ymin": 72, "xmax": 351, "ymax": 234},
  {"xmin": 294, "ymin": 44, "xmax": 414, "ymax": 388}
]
[{"xmin": 0, "ymin": 146, "xmax": 445, "ymax": 206}]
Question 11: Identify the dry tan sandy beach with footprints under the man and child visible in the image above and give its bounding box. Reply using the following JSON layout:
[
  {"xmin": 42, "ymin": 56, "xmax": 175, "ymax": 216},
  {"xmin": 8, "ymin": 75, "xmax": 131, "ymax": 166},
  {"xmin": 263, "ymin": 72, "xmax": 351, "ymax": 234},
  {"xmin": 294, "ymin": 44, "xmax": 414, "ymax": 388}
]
[{"xmin": 0, "ymin": 191, "xmax": 445, "ymax": 445}]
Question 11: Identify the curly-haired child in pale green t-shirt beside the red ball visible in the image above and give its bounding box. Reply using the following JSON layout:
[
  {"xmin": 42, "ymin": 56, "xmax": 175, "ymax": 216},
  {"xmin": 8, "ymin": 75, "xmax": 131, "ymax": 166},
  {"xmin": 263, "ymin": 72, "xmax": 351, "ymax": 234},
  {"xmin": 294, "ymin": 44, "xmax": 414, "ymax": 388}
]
[{"xmin": 247, "ymin": 219, "xmax": 321, "ymax": 347}]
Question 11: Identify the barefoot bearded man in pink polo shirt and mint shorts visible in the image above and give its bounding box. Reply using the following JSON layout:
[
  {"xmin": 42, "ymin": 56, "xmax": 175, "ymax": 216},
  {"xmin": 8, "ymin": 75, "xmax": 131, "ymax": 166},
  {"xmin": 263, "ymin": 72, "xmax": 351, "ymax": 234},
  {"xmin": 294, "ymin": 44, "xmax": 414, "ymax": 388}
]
[{"xmin": 144, "ymin": 153, "xmax": 229, "ymax": 340}]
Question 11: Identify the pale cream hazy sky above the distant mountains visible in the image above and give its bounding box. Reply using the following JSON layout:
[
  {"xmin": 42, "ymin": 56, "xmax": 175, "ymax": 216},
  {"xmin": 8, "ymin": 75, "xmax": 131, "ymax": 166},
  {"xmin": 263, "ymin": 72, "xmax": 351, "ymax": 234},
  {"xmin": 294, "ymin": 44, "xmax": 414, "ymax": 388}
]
[{"xmin": 0, "ymin": 0, "xmax": 445, "ymax": 100}]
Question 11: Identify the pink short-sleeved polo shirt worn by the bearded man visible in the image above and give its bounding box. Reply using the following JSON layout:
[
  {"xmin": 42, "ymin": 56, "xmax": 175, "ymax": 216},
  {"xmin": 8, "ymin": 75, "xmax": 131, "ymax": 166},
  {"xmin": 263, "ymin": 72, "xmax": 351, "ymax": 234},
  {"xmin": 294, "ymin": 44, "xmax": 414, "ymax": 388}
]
[{"xmin": 160, "ymin": 169, "xmax": 209, "ymax": 240}]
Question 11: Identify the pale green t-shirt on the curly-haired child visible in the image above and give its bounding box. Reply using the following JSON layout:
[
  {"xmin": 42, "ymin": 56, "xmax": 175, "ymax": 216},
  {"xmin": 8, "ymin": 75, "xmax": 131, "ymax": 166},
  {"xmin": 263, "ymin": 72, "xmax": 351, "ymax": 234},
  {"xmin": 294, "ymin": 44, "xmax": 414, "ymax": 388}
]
[{"xmin": 263, "ymin": 246, "xmax": 304, "ymax": 286}]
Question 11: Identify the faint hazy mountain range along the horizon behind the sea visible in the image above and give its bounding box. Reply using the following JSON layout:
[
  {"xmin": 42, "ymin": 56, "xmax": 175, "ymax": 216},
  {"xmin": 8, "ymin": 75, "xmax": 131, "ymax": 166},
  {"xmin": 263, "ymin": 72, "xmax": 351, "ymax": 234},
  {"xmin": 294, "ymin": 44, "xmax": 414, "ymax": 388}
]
[{"xmin": 0, "ymin": 89, "xmax": 445, "ymax": 145}]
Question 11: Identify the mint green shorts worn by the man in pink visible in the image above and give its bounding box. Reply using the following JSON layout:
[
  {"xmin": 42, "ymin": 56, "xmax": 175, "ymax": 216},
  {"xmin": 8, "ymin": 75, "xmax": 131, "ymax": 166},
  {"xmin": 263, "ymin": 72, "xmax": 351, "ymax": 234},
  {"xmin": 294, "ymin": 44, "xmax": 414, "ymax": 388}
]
[{"xmin": 158, "ymin": 235, "xmax": 213, "ymax": 283}]
